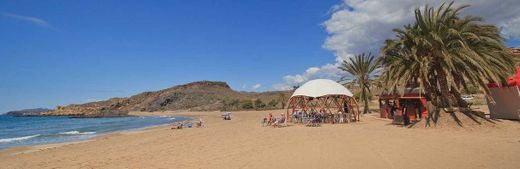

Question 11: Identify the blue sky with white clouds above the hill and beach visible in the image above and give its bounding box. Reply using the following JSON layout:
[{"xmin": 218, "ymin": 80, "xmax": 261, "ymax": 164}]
[{"xmin": 0, "ymin": 0, "xmax": 520, "ymax": 112}]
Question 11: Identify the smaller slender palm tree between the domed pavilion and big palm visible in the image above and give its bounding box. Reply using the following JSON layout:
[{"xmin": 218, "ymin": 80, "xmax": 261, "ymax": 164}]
[{"xmin": 339, "ymin": 53, "xmax": 378, "ymax": 114}]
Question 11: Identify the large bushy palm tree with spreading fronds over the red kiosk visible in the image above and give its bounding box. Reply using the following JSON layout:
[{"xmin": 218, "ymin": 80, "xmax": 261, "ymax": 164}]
[{"xmin": 379, "ymin": 2, "xmax": 515, "ymax": 108}]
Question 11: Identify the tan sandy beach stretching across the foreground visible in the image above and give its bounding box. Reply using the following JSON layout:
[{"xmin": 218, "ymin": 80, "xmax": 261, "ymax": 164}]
[{"xmin": 0, "ymin": 110, "xmax": 520, "ymax": 169}]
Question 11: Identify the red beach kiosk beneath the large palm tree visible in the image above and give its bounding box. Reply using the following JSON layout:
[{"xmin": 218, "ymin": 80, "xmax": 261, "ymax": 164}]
[{"xmin": 379, "ymin": 88, "xmax": 430, "ymax": 125}]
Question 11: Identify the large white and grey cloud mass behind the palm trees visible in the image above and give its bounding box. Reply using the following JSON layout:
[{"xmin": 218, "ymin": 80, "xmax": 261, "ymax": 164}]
[{"xmin": 273, "ymin": 0, "xmax": 520, "ymax": 90}]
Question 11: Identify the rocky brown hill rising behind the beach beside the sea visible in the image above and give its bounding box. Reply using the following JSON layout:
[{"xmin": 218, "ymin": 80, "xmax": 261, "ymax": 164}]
[{"xmin": 44, "ymin": 81, "xmax": 290, "ymax": 117}]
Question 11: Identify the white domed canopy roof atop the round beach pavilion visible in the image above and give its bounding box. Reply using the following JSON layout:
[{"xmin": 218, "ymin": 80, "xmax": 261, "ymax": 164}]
[{"xmin": 291, "ymin": 79, "xmax": 353, "ymax": 97}]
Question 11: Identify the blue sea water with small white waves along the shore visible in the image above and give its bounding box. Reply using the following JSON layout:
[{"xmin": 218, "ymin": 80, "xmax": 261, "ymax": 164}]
[{"xmin": 0, "ymin": 115, "xmax": 189, "ymax": 149}]
